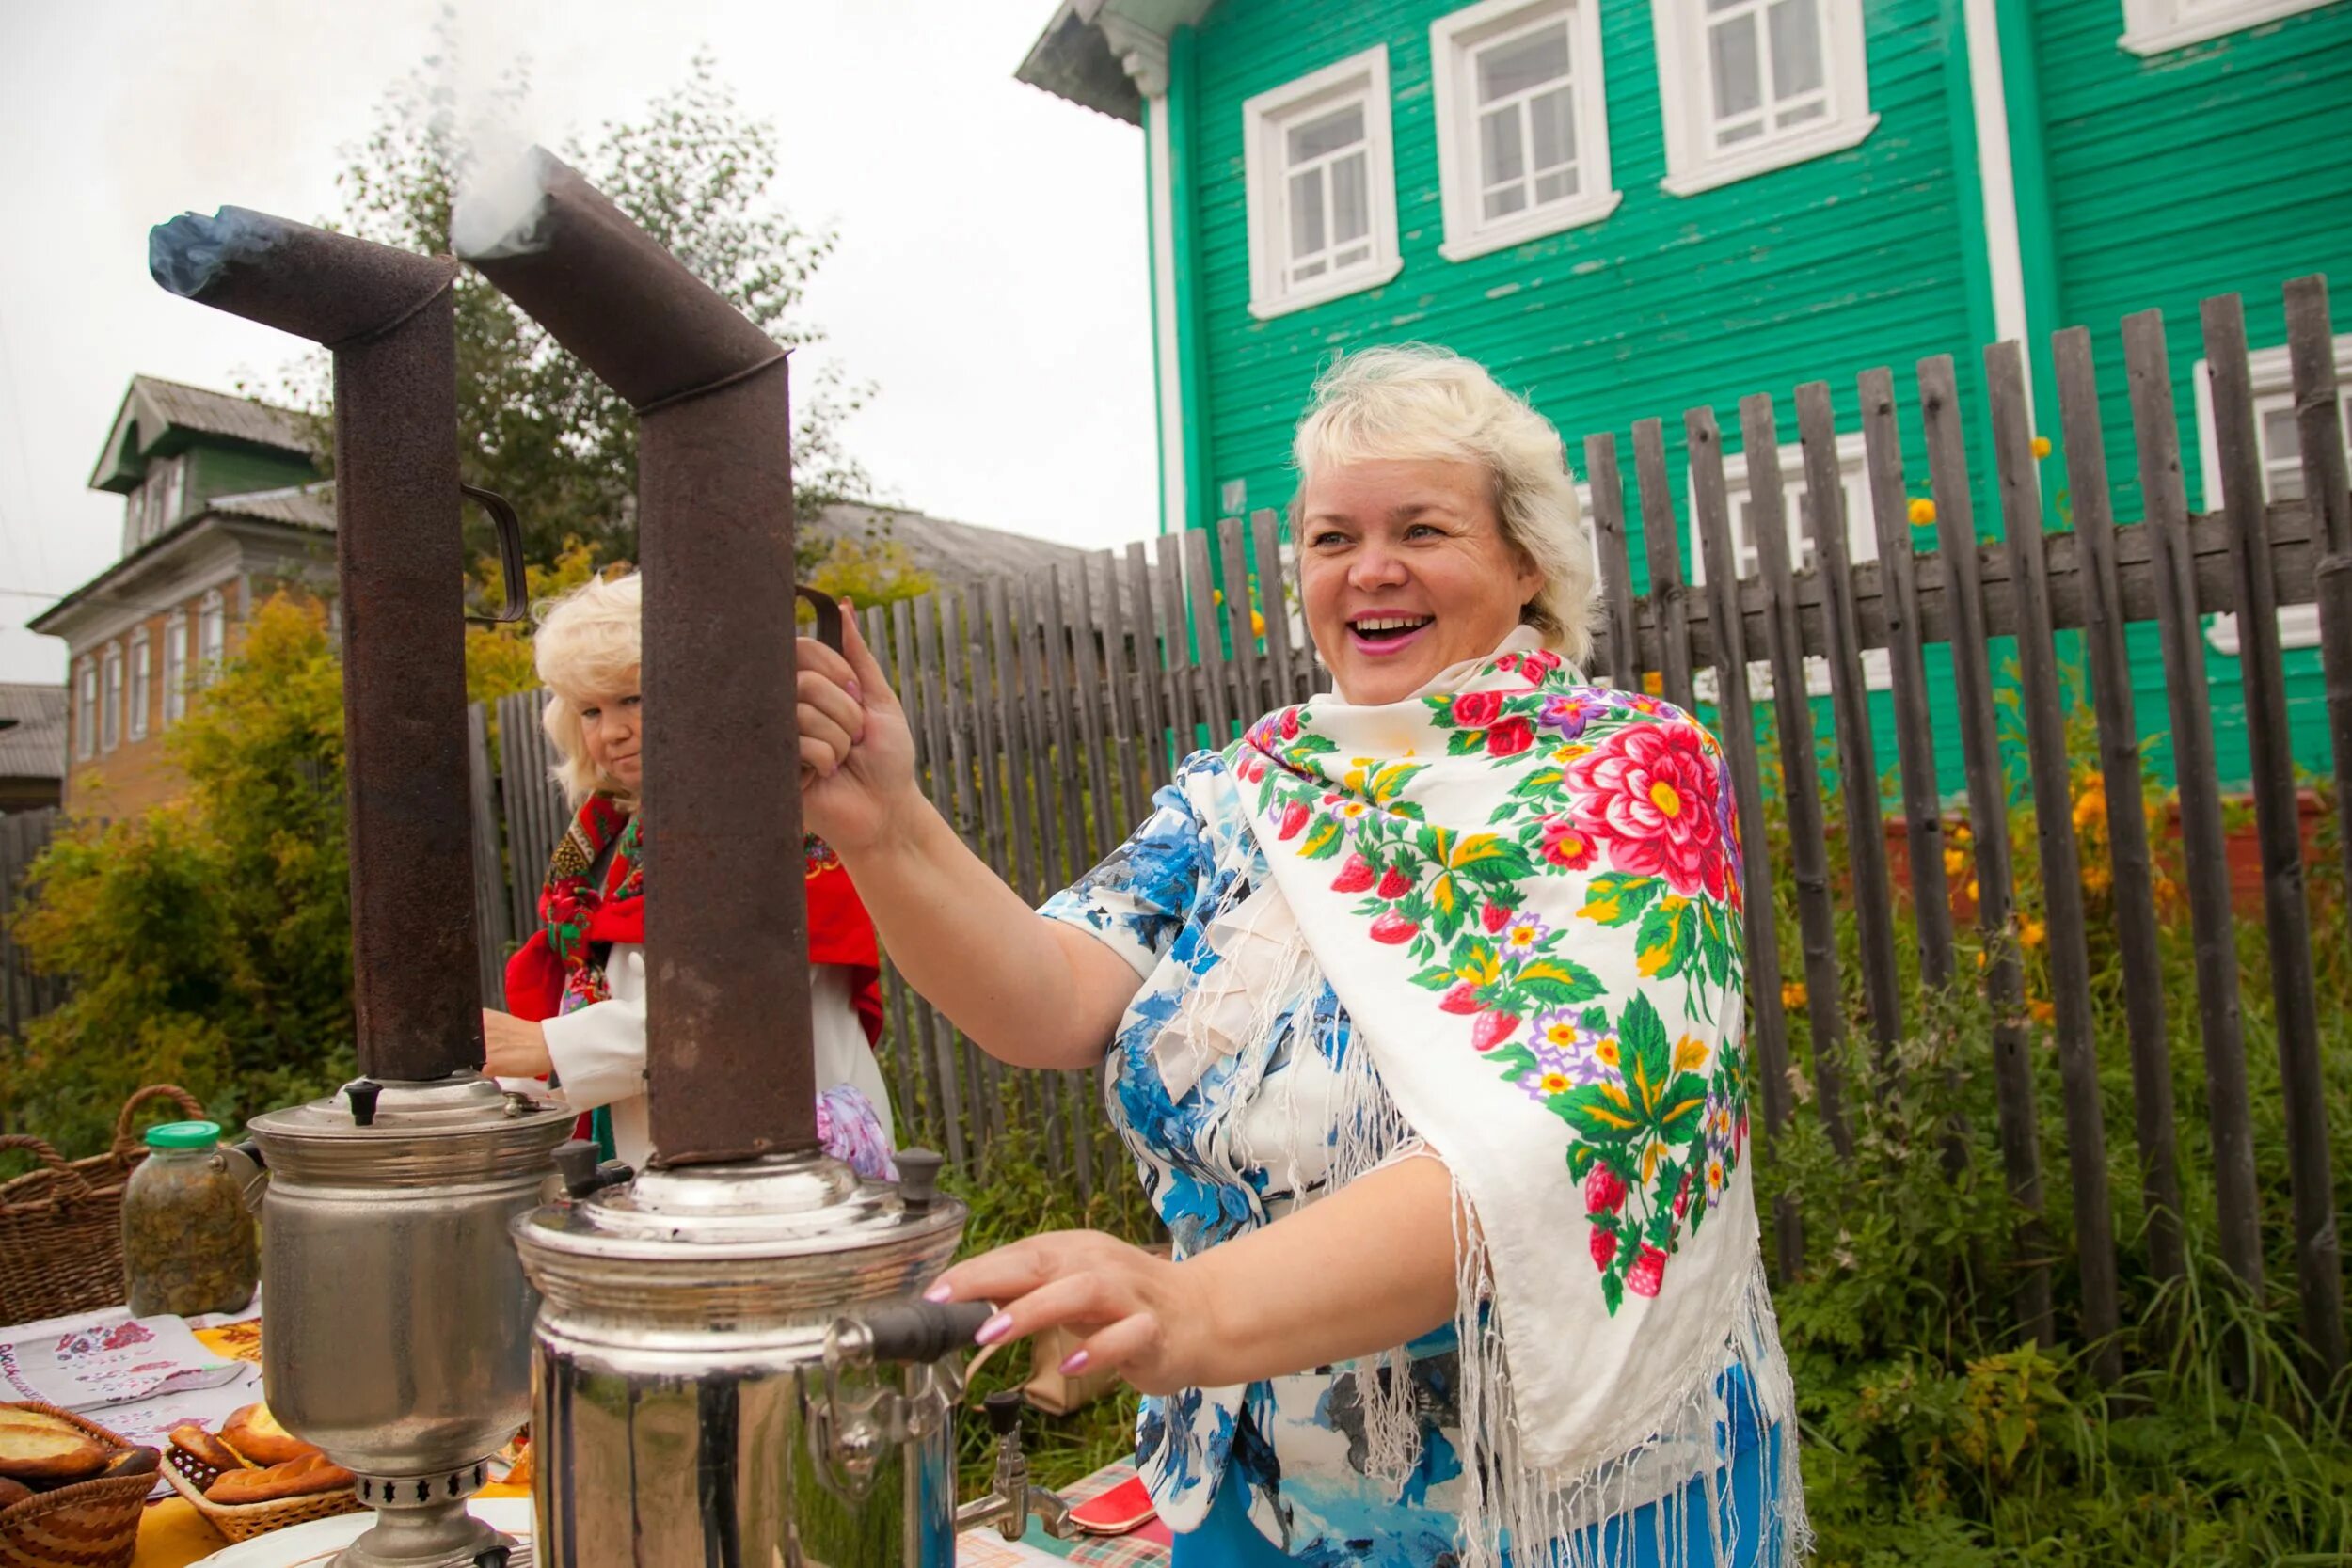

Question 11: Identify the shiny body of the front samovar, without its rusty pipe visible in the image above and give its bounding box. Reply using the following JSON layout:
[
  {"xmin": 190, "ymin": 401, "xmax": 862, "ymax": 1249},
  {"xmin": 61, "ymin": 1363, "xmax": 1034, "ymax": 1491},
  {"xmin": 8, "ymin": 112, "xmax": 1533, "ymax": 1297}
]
[{"xmin": 516, "ymin": 1149, "xmax": 988, "ymax": 1568}]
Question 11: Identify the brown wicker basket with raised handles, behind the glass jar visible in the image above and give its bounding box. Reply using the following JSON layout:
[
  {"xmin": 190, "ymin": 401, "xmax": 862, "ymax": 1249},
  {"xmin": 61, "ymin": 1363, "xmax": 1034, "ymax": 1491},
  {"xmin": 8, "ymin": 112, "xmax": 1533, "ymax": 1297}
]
[{"xmin": 0, "ymin": 1084, "xmax": 205, "ymax": 1323}]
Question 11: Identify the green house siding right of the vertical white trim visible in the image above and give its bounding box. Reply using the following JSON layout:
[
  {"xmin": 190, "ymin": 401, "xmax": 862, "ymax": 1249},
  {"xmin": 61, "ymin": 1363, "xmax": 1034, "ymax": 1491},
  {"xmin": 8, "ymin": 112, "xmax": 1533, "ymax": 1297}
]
[{"xmin": 2027, "ymin": 0, "xmax": 2352, "ymax": 781}]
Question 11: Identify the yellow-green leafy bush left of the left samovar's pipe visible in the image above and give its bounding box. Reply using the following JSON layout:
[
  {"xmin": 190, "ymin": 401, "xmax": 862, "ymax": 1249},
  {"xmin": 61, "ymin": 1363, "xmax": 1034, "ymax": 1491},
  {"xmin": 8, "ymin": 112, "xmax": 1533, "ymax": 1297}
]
[{"xmin": 0, "ymin": 594, "xmax": 353, "ymax": 1154}]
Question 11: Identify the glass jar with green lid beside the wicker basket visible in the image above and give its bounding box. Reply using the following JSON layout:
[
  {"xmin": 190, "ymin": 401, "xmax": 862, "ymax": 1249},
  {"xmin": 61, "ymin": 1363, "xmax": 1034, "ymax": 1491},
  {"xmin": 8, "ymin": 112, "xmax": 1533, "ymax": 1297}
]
[{"xmin": 122, "ymin": 1121, "xmax": 262, "ymax": 1317}]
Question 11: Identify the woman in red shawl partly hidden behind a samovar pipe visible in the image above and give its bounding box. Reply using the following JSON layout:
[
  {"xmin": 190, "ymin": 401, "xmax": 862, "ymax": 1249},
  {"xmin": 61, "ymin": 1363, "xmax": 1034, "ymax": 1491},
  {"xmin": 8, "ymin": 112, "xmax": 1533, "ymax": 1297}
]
[{"xmin": 483, "ymin": 574, "xmax": 897, "ymax": 1178}]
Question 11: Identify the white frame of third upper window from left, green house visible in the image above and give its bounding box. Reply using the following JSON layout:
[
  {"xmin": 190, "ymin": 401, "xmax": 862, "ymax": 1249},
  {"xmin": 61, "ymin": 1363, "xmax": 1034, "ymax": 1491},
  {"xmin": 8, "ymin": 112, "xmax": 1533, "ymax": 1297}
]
[{"xmin": 1649, "ymin": 0, "xmax": 1880, "ymax": 195}]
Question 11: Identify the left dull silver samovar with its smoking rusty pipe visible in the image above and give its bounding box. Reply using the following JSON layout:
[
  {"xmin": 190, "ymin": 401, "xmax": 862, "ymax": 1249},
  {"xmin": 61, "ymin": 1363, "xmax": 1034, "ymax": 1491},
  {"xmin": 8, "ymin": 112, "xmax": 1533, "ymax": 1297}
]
[{"xmin": 149, "ymin": 207, "xmax": 572, "ymax": 1568}]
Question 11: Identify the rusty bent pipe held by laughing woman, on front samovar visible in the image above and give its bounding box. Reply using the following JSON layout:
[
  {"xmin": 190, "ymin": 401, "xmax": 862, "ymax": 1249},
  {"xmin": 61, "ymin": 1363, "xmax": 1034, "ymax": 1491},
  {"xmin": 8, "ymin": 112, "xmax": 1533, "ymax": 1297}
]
[{"xmin": 459, "ymin": 148, "xmax": 821, "ymax": 1166}]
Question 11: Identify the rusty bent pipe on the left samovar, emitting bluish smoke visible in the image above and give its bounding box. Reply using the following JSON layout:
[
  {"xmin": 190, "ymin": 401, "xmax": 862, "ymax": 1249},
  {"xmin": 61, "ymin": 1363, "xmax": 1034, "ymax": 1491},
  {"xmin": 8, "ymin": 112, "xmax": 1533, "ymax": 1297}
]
[{"xmin": 149, "ymin": 207, "xmax": 483, "ymax": 1082}]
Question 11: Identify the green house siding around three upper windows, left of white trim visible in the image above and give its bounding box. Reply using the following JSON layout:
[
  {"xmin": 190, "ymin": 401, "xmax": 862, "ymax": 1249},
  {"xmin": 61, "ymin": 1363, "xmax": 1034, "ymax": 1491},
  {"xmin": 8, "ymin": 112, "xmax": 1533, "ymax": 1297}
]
[{"xmin": 1176, "ymin": 0, "xmax": 1990, "ymax": 792}]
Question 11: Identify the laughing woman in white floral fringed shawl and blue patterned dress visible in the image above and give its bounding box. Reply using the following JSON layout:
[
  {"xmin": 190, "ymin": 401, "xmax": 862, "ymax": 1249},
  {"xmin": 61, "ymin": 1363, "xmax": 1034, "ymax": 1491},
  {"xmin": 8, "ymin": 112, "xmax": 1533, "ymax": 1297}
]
[{"xmin": 800, "ymin": 348, "xmax": 1804, "ymax": 1568}]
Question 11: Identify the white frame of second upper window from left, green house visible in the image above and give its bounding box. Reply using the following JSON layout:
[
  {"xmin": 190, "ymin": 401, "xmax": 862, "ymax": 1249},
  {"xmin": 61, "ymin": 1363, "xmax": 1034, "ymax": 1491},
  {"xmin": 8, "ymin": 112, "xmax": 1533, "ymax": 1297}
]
[{"xmin": 1430, "ymin": 0, "xmax": 1626, "ymax": 261}]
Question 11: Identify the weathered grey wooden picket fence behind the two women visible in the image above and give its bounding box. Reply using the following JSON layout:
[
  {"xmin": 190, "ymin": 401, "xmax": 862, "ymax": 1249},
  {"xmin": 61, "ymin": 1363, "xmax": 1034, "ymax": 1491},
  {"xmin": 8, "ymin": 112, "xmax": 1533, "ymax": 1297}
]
[{"xmin": 437, "ymin": 277, "xmax": 2352, "ymax": 1378}]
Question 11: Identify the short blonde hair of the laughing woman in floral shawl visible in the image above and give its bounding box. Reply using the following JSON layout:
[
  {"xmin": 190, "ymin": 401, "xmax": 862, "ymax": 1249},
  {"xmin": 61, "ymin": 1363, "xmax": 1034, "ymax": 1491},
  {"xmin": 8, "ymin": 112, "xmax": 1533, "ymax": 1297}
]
[{"xmin": 1292, "ymin": 343, "xmax": 1599, "ymax": 665}]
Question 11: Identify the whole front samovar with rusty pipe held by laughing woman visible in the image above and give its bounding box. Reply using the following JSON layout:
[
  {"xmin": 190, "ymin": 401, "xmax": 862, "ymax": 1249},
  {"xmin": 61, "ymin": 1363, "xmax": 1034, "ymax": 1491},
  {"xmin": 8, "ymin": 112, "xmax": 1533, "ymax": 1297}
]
[{"xmin": 454, "ymin": 150, "xmax": 1061, "ymax": 1568}]
